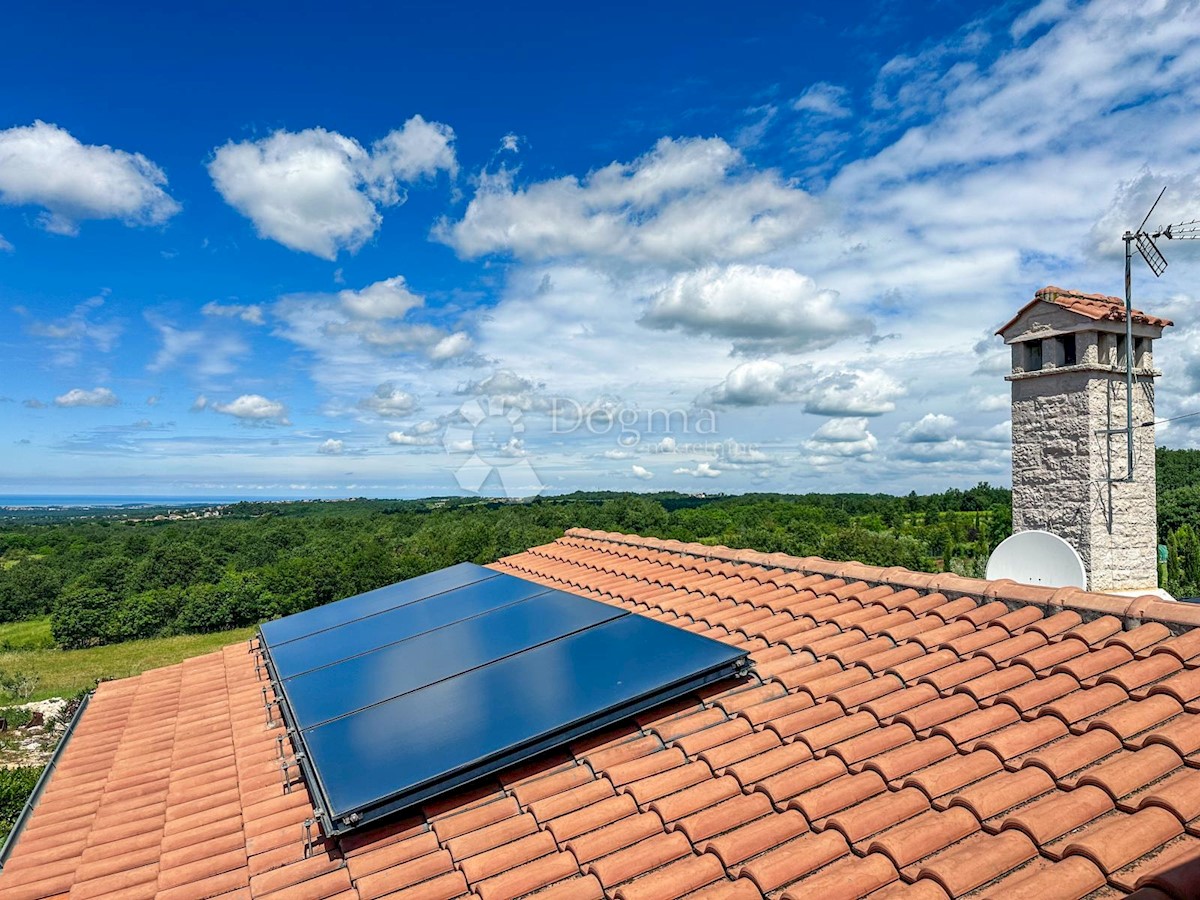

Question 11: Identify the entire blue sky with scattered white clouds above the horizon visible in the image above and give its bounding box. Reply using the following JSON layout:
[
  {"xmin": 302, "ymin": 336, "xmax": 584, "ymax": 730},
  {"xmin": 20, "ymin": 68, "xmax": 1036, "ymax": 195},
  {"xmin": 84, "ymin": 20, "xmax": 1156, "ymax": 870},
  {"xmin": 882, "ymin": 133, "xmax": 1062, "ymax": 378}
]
[{"xmin": 0, "ymin": 0, "xmax": 1200, "ymax": 497}]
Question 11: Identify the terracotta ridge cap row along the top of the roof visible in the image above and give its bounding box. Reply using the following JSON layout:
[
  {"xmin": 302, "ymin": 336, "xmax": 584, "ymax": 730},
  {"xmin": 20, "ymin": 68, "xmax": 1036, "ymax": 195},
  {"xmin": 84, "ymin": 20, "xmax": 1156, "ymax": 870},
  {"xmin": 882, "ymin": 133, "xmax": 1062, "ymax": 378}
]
[{"xmin": 566, "ymin": 528, "xmax": 1200, "ymax": 634}]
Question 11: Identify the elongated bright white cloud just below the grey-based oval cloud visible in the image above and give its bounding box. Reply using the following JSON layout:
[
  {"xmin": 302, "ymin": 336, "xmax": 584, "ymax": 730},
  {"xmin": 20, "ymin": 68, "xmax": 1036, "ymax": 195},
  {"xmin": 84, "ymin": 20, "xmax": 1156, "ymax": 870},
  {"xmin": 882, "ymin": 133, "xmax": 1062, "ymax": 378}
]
[{"xmin": 700, "ymin": 360, "xmax": 905, "ymax": 416}]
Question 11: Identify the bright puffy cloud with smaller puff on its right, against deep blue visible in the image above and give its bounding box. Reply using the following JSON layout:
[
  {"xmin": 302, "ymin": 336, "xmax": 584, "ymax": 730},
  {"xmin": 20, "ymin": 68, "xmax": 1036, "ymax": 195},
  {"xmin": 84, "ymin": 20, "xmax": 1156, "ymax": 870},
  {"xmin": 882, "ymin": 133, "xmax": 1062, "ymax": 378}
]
[{"xmin": 209, "ymin": 115, "xmax": 458, "ymax": 259}]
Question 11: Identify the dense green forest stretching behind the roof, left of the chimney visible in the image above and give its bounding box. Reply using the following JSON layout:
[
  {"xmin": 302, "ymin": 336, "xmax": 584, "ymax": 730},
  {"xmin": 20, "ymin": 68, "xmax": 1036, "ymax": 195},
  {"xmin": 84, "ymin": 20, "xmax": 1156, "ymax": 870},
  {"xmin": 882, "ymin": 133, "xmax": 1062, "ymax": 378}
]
[{"xmin": 0, "ymin": 484, "xmax": 1012, "ymax": 648}]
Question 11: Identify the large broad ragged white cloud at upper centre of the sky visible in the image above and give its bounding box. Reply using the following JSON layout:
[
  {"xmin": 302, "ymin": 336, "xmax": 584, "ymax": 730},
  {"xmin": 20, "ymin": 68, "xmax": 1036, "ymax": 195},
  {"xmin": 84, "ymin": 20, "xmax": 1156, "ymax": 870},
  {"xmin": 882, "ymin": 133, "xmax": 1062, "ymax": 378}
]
[{"xmin": 434, "ymin": 138, "xmax": 815, "ymax": 268}]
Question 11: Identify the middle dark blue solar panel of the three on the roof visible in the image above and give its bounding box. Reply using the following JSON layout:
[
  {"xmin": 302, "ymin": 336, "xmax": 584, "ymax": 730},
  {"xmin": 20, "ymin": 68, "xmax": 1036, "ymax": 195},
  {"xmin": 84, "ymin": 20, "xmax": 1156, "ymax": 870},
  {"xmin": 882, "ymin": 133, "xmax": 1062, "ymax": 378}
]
[{"xmin": 274, "ymin": 590, "xmax": 629, "ymax": 728}]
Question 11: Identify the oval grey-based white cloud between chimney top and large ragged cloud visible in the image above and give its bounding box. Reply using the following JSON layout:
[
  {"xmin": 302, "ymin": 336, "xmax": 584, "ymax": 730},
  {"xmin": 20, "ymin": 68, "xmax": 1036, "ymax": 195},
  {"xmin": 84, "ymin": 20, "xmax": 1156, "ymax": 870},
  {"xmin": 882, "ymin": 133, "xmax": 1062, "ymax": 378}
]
[{"xmin": 642, "ymin": 264, "xmax": 874, "ymax": 352}]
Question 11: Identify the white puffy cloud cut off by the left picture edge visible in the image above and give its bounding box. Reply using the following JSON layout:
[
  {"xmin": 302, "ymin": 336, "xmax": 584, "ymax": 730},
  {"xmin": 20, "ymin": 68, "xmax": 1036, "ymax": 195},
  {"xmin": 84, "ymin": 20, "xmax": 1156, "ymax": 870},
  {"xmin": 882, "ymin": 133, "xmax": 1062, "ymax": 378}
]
[{"xmin": 0, "ymin": 120, "xmax": 180, "ymax": 234}]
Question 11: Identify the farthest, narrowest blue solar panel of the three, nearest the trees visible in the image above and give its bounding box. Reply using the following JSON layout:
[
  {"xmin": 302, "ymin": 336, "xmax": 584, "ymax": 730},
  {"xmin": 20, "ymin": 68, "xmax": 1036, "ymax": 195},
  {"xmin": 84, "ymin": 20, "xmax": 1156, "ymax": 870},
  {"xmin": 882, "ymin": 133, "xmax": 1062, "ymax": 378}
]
[{"xmin": 271, "ymin": 575, "xmax": 550, "ymax": 678}]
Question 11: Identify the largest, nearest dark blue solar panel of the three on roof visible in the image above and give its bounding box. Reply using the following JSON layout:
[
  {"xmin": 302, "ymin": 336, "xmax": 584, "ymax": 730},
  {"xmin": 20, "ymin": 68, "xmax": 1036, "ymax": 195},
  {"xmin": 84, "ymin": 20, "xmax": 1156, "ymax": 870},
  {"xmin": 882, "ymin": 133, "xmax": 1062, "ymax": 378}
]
[{"xmin": 304, "ymin": 616, "xmax": 745, "ymax": 822}]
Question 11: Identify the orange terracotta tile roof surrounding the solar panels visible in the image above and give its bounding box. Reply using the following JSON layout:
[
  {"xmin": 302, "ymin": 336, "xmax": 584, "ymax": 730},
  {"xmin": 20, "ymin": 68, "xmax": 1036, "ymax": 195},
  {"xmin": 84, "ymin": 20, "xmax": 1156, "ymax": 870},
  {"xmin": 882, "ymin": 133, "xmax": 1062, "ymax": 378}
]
[{"xmin": 0, "ymin": 530, "xmax": 1200, "ymax": 900}]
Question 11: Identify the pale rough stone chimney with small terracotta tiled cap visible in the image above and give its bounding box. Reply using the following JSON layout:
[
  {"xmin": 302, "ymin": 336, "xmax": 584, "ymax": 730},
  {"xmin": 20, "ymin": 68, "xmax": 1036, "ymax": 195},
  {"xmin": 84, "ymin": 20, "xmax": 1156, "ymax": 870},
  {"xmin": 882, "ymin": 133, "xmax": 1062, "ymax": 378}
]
[{"xmin": 996, "ymin": 287, "xmax": 1171, "ymax": 592}]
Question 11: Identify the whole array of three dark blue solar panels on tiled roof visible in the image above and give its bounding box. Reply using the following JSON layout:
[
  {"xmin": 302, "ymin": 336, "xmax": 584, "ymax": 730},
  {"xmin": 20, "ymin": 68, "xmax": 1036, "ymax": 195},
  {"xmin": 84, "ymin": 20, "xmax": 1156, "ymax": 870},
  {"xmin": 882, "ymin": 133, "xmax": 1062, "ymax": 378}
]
[{"xmin": 259, "ymin": 566, "xmax": 748, "ymax": 835}]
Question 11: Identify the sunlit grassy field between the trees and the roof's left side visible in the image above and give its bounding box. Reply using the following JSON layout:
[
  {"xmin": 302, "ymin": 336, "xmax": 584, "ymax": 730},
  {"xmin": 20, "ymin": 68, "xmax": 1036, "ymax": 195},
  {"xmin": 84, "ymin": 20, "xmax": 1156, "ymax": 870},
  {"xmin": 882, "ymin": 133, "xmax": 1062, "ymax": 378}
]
[{"xmin": 0, "ymin": 619, "xmax": 254, "ymax": 702}]
